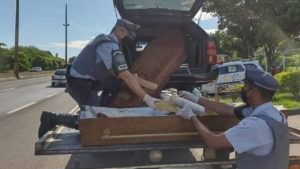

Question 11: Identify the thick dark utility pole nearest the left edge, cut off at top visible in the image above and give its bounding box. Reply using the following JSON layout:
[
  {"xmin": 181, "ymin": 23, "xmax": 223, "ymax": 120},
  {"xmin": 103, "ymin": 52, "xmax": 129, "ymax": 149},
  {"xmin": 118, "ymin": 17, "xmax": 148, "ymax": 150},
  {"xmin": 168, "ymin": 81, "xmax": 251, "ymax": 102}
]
[{"xmin": 14, "ymin": 0, "xmax": 20, "ymax": 79}]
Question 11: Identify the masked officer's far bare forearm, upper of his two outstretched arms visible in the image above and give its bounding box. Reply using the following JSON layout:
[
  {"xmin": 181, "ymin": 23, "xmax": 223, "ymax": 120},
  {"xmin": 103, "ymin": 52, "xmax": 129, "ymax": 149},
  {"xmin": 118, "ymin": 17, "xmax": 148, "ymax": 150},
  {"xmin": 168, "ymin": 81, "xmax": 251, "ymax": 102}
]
[{"xmin": 198, "ymin": 97, "xmax": 234, "ymax": 116}]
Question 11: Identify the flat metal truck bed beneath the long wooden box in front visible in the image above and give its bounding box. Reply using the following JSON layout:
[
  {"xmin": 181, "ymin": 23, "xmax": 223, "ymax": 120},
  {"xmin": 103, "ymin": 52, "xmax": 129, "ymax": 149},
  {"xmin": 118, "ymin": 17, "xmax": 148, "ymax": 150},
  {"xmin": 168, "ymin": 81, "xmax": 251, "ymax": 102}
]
[{"xmin": 35, "ymin": 122, "xmax": 300, "ymax": 169}]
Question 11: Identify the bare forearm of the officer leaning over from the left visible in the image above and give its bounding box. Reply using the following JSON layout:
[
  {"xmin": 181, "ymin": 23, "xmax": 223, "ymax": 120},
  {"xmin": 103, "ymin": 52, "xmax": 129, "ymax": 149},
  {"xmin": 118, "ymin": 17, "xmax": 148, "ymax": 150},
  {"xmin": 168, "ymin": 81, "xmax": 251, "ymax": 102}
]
[{"xmin": 119, "ymin": 70, "xmax": 146, "ymax": 98}]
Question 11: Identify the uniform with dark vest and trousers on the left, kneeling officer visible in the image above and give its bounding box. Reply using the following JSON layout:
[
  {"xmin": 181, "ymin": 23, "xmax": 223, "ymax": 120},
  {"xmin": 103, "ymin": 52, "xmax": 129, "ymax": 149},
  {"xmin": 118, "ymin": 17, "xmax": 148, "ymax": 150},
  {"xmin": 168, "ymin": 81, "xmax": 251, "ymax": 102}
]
[{"xmin": 66, "ymin": 33, "xmax": 128, "ymax": 106}]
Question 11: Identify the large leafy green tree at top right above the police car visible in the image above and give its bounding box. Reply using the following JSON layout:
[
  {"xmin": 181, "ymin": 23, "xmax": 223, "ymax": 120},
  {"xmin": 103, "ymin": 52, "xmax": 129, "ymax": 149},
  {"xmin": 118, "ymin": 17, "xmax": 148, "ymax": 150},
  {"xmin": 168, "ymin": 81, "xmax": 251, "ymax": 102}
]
[{"xmin": 205, "ymin": 0, "xmax": 300, "ymax": 70}]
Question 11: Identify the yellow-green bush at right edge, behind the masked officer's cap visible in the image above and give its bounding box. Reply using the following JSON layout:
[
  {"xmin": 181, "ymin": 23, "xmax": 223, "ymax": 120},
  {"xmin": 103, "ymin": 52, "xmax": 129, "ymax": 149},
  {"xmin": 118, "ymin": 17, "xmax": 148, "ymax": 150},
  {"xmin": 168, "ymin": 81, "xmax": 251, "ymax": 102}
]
[{"xmin": 275, "ymin": 71, "xmax": 300, "ymax": 96}]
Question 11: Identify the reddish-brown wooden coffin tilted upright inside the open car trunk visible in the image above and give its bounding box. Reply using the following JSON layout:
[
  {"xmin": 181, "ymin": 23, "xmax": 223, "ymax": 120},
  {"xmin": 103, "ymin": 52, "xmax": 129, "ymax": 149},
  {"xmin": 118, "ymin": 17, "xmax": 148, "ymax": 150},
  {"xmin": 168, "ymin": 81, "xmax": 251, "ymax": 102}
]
[{"xmin": 109, "ymin": 30, "xmax": 187, "ymax": 108}]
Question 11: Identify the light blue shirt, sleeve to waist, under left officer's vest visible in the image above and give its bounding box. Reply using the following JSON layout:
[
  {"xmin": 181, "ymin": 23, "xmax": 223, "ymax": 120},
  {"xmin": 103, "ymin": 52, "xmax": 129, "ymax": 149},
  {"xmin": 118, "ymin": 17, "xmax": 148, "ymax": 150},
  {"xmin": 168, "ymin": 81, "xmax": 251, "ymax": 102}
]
[{"xmin": 70, "ymin": 33, "xmax": 120, "ymax": 80}]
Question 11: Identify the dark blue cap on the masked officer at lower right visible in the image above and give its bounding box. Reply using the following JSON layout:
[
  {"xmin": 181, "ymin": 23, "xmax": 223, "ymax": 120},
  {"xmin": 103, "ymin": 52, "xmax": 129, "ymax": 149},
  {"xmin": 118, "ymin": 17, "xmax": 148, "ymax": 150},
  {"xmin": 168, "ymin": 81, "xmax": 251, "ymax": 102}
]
[{"xmin": 244, "ymin": 67, "xmax": 279, "ymax": 91}]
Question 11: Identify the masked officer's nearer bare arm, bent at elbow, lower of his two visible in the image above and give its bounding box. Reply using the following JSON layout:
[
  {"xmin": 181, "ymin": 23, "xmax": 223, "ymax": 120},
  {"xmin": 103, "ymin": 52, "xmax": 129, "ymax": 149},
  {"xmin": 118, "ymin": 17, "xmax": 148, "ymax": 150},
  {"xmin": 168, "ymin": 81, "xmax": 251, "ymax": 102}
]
[{"xmin": 192, "ymin": 116, "xmax": 231, "ymax": 148}]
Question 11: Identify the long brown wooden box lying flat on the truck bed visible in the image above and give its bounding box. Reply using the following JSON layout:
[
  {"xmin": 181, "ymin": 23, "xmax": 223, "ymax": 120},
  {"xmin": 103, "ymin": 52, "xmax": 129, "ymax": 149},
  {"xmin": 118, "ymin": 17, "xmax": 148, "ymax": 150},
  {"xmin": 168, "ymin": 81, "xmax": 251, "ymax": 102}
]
[{"xmin": 79, "ymin": 115, "xmax": 238, "ymax": 146}]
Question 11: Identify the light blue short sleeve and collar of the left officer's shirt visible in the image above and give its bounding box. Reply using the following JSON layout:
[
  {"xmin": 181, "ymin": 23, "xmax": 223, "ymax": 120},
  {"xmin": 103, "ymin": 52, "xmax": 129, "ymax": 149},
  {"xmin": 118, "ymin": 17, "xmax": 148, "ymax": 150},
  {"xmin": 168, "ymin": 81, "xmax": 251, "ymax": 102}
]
[{"xmin": 96, "ymin": 33, "xmax": 120, "ymax": 69}]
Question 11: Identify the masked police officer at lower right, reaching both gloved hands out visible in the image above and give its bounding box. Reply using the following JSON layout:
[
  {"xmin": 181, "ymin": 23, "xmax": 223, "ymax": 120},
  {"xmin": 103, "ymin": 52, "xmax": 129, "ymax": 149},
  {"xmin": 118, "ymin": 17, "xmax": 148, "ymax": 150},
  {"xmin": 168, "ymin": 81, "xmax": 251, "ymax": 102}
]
[{"xmin": 179, "ymin": 67, "xmax": 289, "ymax": 169}]
